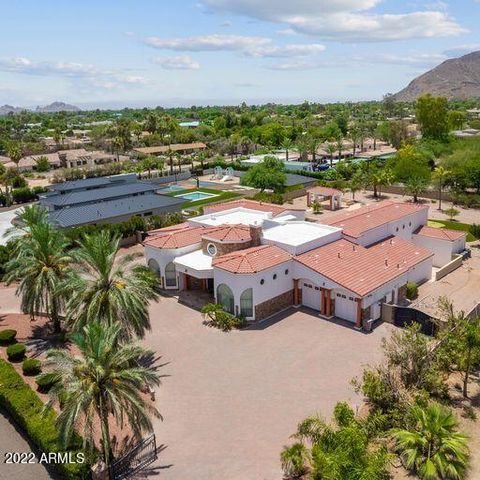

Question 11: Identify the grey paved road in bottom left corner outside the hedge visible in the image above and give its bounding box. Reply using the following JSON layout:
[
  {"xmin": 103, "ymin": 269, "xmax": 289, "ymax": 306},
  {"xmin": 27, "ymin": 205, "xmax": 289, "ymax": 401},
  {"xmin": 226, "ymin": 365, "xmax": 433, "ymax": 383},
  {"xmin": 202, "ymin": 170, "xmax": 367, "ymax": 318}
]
[{"xmin": 0, "ymin": 412, "xmax": 54, "ymax": 480}]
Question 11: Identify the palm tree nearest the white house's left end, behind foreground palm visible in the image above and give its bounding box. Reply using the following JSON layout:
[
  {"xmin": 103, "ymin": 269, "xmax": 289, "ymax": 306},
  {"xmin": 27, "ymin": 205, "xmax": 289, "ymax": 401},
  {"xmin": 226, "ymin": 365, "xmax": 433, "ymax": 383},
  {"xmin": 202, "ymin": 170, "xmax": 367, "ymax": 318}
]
[{"xmin": 62, "ymin": 231, "xmax": 158, "ymax": 339}]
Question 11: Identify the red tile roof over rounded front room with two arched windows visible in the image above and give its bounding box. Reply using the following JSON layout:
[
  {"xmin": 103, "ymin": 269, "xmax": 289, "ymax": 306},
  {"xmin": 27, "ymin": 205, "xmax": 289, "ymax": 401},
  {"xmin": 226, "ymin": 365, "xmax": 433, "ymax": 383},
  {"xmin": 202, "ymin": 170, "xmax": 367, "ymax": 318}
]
[{"xmin": 212, "ymin": 245, "xmax": 292, "ymax": 273}]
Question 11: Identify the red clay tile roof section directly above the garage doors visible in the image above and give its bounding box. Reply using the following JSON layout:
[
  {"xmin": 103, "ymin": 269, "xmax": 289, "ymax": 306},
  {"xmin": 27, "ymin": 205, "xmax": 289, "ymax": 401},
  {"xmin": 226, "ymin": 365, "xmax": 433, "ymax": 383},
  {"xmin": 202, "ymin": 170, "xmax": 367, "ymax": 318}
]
[{"xmin": 295, "ymin": 237, "xmax": 433, "ymax": 297}]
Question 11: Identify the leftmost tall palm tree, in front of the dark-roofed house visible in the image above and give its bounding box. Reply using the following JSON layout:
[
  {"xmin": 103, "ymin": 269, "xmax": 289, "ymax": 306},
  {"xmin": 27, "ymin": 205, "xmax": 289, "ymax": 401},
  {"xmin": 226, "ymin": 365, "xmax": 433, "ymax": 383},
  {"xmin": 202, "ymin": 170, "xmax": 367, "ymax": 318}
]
[{"xmin": 5, "ymin": 222, "xmax": 72, "ymax": 333}]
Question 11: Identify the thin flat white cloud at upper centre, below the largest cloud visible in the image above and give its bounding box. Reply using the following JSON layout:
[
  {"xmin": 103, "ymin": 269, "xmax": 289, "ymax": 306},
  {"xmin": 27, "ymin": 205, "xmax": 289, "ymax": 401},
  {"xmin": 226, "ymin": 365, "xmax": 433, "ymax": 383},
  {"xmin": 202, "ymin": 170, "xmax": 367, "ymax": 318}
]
[{"xmin": 145, "ymin": 34, "xmax": 271, "ymax": 52}]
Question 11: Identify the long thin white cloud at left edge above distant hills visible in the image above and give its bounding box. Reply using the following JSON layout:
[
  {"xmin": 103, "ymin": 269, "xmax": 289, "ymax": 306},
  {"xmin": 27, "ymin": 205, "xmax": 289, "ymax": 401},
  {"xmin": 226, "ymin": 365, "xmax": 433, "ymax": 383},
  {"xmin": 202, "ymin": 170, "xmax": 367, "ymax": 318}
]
[{"xmin": 0, "ymin": 57, "xmax": 147, "ymax": 89}]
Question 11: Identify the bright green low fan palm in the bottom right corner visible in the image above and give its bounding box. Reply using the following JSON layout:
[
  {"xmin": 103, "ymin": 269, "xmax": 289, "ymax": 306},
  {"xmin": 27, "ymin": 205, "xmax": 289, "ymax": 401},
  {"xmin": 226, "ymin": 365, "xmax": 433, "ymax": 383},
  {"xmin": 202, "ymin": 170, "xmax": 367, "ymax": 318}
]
[{"xmin": 392, "ymin": 403, "xmax": 469, "ymax": 480}]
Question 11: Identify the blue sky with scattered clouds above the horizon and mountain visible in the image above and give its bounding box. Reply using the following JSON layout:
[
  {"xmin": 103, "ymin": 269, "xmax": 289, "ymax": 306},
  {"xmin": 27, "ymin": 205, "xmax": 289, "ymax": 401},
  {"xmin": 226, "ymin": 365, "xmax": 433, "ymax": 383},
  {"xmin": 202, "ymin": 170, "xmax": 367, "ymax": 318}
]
[{"xmin": 0, "ymin": 0, "xmax": 480, "ymax": 107}]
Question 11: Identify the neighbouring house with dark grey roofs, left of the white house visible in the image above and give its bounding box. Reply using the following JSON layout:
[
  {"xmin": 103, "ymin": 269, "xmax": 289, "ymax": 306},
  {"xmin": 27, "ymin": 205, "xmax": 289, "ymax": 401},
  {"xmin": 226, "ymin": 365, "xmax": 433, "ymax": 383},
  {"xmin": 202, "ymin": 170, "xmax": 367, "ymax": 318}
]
[{"xmin": 39, "ymin": 174, "xmax": 185, "ymax": 228}]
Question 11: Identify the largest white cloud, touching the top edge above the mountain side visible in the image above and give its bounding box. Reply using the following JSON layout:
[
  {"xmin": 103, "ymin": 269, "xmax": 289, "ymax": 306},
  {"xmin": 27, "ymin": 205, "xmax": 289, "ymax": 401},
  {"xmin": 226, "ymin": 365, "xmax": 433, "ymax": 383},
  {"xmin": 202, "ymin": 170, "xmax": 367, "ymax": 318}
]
[{"xmin": 204, "ymin": 0, "xmax": 466, "ymax": 42}]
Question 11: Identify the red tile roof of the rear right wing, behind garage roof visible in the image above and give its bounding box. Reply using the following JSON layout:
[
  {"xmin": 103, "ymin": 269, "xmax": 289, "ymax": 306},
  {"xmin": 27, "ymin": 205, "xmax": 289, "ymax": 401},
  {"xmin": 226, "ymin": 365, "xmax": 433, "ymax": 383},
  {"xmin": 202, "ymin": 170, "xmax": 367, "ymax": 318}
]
[{"xmin": 324, "ymin": 200, "xmax": 428, "ymax": 238}]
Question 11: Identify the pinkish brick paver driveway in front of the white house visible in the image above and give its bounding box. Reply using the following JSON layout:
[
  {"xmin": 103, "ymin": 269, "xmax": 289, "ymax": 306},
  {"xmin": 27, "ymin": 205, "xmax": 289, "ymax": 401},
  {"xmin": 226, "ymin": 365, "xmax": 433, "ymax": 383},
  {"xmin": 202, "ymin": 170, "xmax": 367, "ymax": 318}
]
[{"xmin": 146, "ymin": 298, "xmax": 393, "ymax": 480}]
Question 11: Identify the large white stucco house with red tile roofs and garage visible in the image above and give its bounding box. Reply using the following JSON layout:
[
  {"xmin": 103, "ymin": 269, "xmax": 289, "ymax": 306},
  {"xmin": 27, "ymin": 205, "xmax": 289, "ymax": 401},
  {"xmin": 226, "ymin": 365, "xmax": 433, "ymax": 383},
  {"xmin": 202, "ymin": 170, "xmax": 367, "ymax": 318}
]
[{"xmin": 144, "ymin": 200, "xmax": 465, "ymax": 327}]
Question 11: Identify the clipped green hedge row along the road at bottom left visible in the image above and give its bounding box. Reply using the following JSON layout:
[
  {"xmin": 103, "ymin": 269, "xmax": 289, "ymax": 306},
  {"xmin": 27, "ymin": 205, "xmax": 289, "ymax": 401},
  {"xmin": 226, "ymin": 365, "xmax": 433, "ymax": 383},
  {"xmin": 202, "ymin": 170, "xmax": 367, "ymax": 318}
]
[{"xmin": 0, "ymin": 359, "xmax": 89, "ymax": 480}]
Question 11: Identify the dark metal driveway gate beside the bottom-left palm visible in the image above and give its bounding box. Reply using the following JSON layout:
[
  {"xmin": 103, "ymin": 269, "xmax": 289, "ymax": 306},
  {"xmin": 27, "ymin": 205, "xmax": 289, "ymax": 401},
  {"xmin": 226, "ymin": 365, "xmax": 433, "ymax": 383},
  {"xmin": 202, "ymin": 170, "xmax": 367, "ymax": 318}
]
[{"xmin": 108, "ymin": 434, "xmax": 157, "ymax": 480}]
